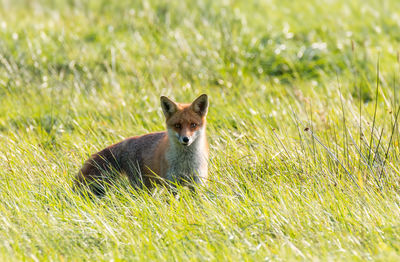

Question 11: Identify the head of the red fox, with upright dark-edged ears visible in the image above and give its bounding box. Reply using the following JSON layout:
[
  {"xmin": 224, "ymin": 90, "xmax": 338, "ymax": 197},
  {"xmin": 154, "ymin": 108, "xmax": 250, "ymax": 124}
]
[{"xmin": 160, "ymin": 94, "xmax": 208, "ymax": 146}]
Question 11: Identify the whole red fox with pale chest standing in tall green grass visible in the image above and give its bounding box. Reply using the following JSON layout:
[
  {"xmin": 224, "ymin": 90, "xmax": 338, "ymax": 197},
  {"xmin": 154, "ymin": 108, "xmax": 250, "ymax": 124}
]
[{"xmin": 75, "ymin": 94, "xmax": 209, "ymax": 197}]
